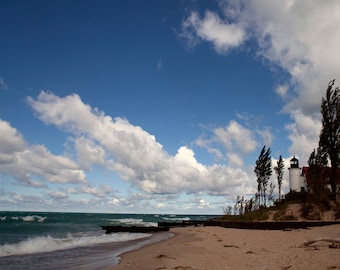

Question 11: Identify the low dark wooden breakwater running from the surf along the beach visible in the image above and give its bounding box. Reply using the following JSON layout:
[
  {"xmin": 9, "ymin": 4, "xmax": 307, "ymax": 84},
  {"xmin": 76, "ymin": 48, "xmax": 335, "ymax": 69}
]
[{"xmin": 101, "ymin": 220, "xmax": 340, "ymax": 234}]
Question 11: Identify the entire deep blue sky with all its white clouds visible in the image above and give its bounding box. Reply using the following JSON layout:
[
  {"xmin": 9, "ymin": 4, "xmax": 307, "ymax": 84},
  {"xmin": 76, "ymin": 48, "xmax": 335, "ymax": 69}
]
[{"xmin": 0, "ymin": 0, "xmax": 340, "ymax": 214}]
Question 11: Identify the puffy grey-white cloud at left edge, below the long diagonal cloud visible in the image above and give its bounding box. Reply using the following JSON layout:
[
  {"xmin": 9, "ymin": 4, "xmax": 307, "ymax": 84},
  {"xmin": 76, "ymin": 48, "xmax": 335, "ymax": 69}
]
[{"xmin": 0, "ymin": 120, "xmax": 86, "ymax": 187}]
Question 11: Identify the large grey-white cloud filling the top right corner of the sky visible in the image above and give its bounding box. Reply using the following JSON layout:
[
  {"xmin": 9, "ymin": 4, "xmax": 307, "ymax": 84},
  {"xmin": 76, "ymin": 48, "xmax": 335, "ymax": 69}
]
[{"xmin": 244, "ymin": 0, "xmax": 340, "ymax": 115}]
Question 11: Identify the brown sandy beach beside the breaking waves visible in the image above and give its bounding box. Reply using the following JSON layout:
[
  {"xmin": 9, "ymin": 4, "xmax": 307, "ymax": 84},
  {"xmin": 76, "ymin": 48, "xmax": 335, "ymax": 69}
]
[{"xmin": 110, "ymin": 225, "xmax": 340, "ymax": 270}]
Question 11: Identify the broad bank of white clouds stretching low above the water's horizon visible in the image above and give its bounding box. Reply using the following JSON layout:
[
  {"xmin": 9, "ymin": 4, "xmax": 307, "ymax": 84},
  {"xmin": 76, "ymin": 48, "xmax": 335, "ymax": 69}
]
[{"xmin": 0, "ymin": 91, "xmax": 271, "ymax": 211}]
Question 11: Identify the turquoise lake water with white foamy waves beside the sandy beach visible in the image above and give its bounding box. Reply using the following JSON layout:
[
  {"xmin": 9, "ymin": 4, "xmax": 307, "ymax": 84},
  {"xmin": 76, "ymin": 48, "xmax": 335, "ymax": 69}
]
[{"xmin": 0, "ymin": 212, "xmax": 218, "ymax": 269}]
